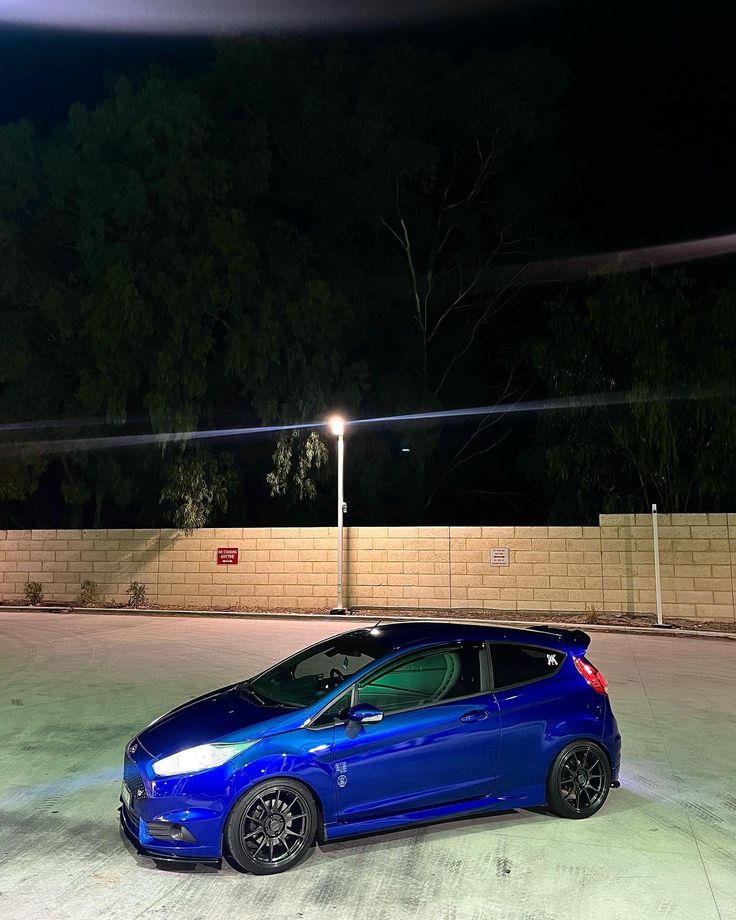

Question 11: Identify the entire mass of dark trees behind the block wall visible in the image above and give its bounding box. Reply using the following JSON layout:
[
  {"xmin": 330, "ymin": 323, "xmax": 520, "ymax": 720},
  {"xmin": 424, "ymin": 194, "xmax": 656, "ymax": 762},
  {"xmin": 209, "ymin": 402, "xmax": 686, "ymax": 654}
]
[{"xmin": 0, "ymin": 40, "xmax": 736, "ymax": 530}]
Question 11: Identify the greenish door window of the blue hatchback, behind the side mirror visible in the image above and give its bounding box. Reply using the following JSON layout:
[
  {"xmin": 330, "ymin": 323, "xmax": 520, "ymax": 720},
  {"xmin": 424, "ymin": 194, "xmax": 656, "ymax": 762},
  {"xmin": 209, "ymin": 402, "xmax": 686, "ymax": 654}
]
[{"xmin": 358, "ymin": 644, "xmax": 483, "ymax": 713}]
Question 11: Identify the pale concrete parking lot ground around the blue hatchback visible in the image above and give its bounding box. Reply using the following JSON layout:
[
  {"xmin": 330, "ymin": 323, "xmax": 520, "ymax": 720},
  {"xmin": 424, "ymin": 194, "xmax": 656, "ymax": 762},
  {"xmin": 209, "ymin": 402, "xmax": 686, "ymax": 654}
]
[{"xmin": 0, "ymin": 612, "xmax": 736, "ymax": 920}]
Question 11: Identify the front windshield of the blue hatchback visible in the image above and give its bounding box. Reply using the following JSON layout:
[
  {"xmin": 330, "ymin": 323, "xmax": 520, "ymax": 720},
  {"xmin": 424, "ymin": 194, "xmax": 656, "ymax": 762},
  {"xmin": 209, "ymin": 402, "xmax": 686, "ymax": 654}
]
[{"xmin": 241, "ymin": 629, "xmax": 388, "ymax": 709}]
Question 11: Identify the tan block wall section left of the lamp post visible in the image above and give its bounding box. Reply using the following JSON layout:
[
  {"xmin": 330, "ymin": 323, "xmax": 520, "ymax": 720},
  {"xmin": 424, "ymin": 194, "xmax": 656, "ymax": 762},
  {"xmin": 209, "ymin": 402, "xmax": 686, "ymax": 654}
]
[{"xmin": 0, "ymin": 527, "xmax": 337, "ymax": 609}]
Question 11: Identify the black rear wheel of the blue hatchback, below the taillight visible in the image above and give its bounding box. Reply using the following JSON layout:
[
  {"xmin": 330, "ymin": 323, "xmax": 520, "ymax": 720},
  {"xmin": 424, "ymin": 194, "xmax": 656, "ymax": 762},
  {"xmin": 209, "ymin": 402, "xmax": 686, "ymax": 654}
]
[{"xmin": 547, "ymin": 741, "xmax": 611, "ymax": 818}]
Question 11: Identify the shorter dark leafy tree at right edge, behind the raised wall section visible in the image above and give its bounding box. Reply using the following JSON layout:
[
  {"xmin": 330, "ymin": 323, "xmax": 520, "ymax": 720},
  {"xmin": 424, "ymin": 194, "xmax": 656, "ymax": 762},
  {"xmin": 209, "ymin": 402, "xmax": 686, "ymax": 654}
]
[{"xmin": 534, "ymin": 273, "xmax": 736, "ymax": 521}]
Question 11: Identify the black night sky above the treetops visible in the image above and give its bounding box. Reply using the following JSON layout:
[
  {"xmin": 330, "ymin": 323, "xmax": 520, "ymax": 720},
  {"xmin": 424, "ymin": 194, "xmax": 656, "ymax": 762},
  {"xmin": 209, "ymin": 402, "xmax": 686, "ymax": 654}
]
[{"xmin": 5, "ymin": 0, "xmax": 736, "ymax": 249}]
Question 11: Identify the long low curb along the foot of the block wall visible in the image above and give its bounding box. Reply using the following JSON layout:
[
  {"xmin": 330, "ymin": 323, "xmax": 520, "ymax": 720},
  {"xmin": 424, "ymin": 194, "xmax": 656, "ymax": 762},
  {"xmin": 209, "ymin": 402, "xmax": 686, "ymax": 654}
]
[{"xmin": 0, "ymin": 604, "xmax": 736, "ymax": 642}]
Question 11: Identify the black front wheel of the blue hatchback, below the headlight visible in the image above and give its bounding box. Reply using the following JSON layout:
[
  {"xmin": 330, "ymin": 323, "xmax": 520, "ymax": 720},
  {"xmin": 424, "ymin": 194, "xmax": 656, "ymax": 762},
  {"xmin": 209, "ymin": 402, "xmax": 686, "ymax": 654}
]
[{"xmin": 223, "ymin": 778, "xmax": 318, "ymax": 875}]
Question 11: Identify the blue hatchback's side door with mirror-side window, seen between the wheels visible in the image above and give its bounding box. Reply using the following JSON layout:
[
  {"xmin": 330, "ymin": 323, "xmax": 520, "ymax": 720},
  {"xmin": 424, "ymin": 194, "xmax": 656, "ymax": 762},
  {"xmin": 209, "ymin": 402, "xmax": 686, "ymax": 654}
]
[{"xmin": 334, "ymin": 643, "xmax": 499, "ymax": 821}]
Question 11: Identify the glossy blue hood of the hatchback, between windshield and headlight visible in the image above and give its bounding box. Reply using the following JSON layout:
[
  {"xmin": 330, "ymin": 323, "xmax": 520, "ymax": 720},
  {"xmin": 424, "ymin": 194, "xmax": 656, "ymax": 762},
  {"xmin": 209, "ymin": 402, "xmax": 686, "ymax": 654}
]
[{"xmin": 138, "ymin": 684, "xmax": 306, "ymax": 757}]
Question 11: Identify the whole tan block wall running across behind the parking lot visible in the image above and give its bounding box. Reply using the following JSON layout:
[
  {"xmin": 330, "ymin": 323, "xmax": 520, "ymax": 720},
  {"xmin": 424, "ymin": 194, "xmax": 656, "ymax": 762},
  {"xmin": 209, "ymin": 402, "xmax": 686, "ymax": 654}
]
[{"xmin": 0, "ymin": 514, "xmax": 736, "ymax": 621}]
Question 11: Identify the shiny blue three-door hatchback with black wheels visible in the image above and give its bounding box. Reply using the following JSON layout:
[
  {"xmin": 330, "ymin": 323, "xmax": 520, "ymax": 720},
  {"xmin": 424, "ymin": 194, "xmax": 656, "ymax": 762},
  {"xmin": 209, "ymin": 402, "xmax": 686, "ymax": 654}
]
[{"xmin": 120, "ymin": 621, "xmax": 621, "ymax": 875}]
